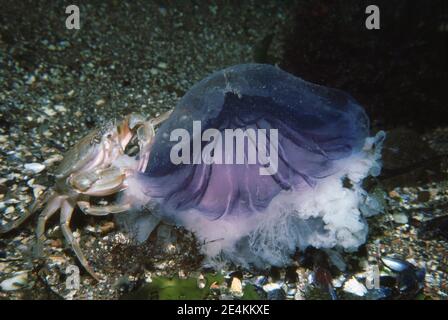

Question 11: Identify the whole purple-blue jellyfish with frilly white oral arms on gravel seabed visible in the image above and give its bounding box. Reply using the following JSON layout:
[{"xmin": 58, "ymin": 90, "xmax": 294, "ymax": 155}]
[{"xmin": 116, "ymin": 64, "xmax": 384, "ymax": 267}]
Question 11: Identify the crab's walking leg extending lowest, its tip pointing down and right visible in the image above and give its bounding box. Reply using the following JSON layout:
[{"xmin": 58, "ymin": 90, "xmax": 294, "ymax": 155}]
[{"xmin": 61, "ymin": 199, "xmax": 100, "ymax": 281}]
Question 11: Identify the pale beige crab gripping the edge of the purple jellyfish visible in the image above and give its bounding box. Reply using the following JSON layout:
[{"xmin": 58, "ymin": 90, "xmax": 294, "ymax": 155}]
[{"xmin": 0, "ymin": 111, "xmax": 171, "ymax": 281}]
